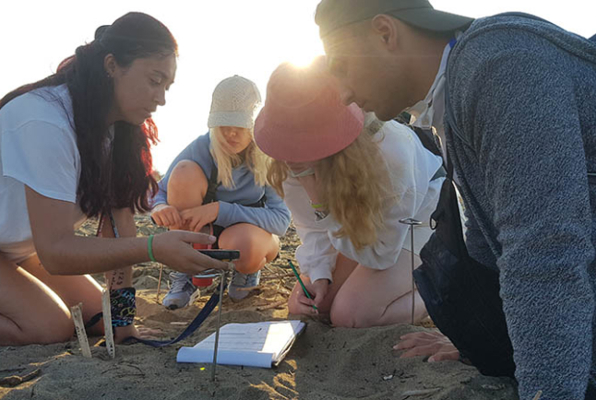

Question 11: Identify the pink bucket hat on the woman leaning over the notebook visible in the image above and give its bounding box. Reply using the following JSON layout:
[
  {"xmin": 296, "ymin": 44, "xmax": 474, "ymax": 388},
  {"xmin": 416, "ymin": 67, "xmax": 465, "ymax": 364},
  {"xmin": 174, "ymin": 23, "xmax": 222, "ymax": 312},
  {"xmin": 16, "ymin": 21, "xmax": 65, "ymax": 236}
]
[{"xmin": 255, "ymin": 57, "xmax": 364, "ymax": 162}]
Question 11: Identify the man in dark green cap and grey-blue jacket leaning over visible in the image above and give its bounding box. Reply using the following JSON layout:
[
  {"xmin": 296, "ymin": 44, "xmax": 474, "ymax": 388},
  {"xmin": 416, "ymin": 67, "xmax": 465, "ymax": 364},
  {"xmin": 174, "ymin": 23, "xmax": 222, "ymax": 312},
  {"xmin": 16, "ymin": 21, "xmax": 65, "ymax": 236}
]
[{"xmin": 315, "ymin": 0, "xmax": 596, "ymax": 400}]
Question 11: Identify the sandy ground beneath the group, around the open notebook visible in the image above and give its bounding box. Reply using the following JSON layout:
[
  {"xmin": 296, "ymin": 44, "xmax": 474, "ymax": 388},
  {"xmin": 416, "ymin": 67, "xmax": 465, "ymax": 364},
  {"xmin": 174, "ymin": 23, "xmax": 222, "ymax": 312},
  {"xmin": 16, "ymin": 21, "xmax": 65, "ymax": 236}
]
[{"xmin": 0, "ymin": 216, "xmax": 517, "ymax": 400}]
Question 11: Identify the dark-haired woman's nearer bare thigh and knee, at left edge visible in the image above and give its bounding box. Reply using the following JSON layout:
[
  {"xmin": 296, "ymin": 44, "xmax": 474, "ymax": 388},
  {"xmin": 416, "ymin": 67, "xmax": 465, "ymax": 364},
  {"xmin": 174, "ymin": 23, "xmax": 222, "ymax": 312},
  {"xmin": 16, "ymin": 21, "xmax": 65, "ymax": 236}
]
[{"xmin": 0, "ymin": 254, "xmax": 74, "ymax": 346}]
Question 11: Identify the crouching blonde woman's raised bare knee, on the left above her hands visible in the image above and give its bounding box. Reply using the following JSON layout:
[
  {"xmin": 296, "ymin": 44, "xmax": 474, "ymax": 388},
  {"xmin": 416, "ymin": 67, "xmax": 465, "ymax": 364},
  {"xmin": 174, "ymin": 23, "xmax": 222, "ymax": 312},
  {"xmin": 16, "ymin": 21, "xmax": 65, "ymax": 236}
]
[{"xmin": 168, "ymin": 160, "xmax": 209, "ymax": 230}]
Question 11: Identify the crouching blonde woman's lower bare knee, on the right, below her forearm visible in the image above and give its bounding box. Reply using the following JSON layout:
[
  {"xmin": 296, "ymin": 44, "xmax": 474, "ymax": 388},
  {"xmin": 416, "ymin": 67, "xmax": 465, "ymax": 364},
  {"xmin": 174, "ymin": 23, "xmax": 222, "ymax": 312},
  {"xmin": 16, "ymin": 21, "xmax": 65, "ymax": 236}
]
[{"xmin": 219, "ymin": 224, "xmax": 279, "ymax": 274}]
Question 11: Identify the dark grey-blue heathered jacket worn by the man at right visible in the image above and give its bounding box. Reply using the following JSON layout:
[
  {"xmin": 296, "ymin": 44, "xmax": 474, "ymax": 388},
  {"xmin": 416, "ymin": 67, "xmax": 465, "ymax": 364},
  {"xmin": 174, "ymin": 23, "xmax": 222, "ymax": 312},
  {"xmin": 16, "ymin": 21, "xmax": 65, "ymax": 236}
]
[{"xmin": 446, "ymin": 16, "xmax": 596, "ymax": 400}]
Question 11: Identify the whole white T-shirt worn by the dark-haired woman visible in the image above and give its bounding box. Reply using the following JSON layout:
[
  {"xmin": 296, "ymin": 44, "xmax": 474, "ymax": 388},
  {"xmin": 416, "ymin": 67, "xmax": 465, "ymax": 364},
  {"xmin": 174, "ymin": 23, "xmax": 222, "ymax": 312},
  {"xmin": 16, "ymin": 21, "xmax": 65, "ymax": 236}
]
[{"xmin": 0, "ymin": 85, "xmax": 85, "ymax": 259}]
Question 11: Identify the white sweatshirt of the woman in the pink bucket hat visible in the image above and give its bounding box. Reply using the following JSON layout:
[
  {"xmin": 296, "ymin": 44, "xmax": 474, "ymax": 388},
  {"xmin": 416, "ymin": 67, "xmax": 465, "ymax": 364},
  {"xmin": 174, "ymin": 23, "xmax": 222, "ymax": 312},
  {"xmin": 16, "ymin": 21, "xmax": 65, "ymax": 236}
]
[{"xmin": 283, "ymin": 121, "xmax": 444, "ymax": 282}]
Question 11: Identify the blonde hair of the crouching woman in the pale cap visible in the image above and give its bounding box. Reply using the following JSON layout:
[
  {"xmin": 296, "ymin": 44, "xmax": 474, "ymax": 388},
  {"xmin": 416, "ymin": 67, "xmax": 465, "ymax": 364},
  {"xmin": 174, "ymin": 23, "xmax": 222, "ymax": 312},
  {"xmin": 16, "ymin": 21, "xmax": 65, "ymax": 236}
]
[{"xmin": 209, "ymin": 126, "xmax": 269, "ymax": 188}]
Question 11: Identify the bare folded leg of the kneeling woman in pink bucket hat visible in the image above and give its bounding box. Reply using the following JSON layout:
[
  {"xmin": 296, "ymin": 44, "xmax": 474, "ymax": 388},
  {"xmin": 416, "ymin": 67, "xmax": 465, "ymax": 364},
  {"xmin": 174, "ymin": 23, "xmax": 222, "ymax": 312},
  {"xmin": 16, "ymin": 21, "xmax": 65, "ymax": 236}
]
[{"xmin": 331, "ymin": 249, "xmax": 427, "ymax": 328}]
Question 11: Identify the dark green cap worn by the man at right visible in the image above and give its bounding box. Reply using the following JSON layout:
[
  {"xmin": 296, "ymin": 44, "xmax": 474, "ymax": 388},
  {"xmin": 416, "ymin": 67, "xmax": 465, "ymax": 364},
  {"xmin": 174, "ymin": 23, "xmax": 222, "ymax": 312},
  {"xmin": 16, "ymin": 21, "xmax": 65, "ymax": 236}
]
[{"xmin": 315, "ymin": 0, "xmax": 474, "ymax": 37}]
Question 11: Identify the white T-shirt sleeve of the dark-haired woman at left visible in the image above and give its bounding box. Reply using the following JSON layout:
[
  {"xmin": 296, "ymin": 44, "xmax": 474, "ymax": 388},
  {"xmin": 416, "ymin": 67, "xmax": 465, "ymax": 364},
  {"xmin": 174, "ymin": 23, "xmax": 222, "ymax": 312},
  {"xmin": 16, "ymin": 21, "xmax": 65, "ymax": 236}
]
[{"xmin": 1, "ymin": 121, "xmax": 80, "ymax": 203}]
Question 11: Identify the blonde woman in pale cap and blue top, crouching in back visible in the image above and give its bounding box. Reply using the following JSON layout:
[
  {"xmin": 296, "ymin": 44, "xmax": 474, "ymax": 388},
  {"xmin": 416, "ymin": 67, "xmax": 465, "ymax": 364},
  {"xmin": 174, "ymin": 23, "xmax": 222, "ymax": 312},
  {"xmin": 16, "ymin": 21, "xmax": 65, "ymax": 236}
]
[{"xmin": 151, "ymin": 75, "xmax": 290, "ymax": 309}]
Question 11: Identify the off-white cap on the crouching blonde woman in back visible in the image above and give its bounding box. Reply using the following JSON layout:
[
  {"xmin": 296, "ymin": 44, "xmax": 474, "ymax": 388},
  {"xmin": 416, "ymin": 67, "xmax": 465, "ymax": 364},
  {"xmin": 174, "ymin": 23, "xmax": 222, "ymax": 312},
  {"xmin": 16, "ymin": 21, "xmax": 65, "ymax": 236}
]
[{"xmin": 207, "ymin": 75, "xmax": 261, "ymax": 129}]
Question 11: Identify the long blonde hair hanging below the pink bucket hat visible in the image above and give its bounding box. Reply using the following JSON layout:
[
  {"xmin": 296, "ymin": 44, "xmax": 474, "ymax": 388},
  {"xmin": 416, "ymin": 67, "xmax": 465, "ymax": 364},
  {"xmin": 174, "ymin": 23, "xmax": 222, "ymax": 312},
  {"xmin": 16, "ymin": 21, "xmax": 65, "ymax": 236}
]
[{"xmin": 267, "ymin": 120, "xmax": 396, "ymax": 250}]
